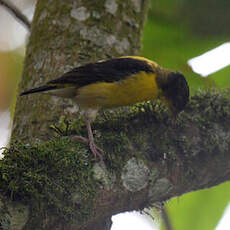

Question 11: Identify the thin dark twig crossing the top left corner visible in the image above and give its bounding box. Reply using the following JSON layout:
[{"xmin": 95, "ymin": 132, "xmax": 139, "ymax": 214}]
[{"xmin": 0, "ymin": 0, "xmax": 30, "ymax": 30}]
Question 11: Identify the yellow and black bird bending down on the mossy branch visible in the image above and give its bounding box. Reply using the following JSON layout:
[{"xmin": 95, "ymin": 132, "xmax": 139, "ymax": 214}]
[{"xmin": 20, "ymin": 56, "xmax": 189, "ymax": 160}]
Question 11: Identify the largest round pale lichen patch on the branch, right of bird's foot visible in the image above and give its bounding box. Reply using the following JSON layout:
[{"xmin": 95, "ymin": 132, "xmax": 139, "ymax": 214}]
[{"xmin": 121, "ymin": 158, "xmax": 150, "ymax": 192}]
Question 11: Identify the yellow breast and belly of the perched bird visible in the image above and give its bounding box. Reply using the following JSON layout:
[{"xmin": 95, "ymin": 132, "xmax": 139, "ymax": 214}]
[{"xmin": 76, "ymin": 72, "xmax": 160, "ymax": 109}]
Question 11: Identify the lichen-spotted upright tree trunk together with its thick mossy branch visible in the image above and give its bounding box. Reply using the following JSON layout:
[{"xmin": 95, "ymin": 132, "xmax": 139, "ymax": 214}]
[{"xmin": 0, "ymin": 0, "xmax": 230, "ymax": 230}]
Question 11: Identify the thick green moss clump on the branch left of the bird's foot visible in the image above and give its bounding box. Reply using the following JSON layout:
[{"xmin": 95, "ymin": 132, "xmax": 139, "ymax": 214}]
[{"xmin": 0, "ymin": 137, "xmax": 98, "ymax": 221}]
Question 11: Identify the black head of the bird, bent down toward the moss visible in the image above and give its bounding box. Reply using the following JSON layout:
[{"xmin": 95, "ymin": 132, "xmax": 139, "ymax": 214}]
[{"xmin": 160, "ymin": 71, "xmax": 189, "ymax": 116}]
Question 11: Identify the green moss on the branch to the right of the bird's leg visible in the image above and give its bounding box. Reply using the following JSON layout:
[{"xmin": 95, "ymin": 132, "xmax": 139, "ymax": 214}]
[{"xmin": 91, "ymin": 90, "xmax": 230, "ymax": 165}]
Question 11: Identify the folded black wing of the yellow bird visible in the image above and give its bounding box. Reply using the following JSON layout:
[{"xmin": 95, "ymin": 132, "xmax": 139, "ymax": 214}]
[{"xmin": 48, "ymin": 57, "xmax": 154, "ymax": 87}]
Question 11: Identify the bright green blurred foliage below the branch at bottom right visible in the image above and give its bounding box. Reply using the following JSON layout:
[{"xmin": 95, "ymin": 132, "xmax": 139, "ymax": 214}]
[{"xmin": 161, "ymin": 182, "xmax": 230, "ymax": 230}]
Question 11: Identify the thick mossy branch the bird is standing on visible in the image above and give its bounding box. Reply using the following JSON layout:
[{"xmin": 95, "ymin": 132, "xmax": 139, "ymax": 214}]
[{"xmin": 0, "ymin": 91, "xmax": 230, "ymax": 230}]
